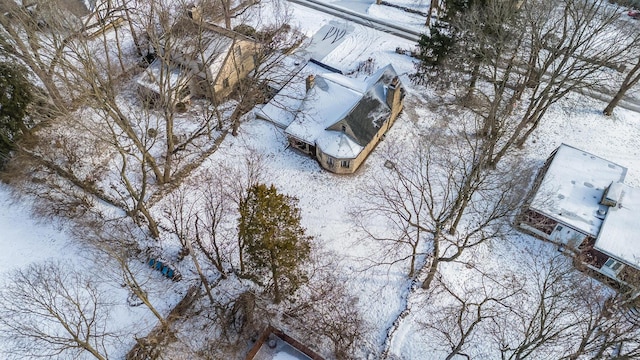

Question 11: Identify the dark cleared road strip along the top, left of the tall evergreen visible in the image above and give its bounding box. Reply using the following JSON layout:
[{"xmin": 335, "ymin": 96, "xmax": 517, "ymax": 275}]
[{"xmin": 289, "ymin": 0, "xmax": 420, "ymax": 42}]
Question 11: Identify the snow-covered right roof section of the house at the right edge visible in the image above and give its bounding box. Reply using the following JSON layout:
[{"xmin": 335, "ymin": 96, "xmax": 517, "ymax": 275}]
[{"xmin": 594, "ymin": 183, "xmax": 640, "ymax": 268}]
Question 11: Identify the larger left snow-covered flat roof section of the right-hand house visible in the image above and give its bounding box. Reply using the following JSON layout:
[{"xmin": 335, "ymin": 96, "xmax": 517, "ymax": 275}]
[{"xmin": 530, "ymin": 144, "xmax": 627, "ymax": 237}]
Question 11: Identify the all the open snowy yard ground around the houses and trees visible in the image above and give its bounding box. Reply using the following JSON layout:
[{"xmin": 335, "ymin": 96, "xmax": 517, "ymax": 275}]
[{"xmin": 0, "ymin": 0, "xmax": 640, "ymax": 359}]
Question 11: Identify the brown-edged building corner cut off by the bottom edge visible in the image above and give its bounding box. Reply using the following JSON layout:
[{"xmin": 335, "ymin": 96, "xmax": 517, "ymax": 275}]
[{"xmin": 245, "ymin": 326, "xmax": 323, "ymax": 360}]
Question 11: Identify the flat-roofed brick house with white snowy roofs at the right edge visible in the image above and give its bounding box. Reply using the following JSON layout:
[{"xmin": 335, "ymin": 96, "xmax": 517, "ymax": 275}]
[{"xmin": 518, "ymin": 144, "xmax": 640, "ymax": 292}]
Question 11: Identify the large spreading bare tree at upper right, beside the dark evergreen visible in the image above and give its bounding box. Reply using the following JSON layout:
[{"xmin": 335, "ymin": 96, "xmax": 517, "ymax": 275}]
[{"xmin": 418, "ymin": 0, "xmax": 638, "ymax": 165}]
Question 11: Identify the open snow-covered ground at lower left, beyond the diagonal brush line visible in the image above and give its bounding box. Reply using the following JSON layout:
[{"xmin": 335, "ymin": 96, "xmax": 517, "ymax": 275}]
[{"xmin": 0, "ymin": 184, "xmax": 184, "ymax": 359}]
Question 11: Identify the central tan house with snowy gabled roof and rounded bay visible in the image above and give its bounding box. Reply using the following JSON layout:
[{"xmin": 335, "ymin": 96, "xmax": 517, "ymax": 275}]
[{"xmin": 285, "ymin": 65, "xmax": 405, "ymax": 174}]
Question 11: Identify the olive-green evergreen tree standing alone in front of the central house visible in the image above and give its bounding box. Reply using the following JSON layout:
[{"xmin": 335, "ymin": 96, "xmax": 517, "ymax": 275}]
[{"xmin": 238, "ymin": 184, "xmax": 311, "ymax": 303}]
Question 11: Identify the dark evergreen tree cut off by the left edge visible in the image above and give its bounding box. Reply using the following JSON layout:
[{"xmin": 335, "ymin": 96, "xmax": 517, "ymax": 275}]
[{"xmin": 0, "ymin": 62, "xmax": 33, "ymax": 168}]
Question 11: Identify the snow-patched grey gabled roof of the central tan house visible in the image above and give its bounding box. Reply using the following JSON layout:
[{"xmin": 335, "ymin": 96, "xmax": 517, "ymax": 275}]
[{"xmin": 285, "ymin": 65, "xmax": 397, "ymax": 159}]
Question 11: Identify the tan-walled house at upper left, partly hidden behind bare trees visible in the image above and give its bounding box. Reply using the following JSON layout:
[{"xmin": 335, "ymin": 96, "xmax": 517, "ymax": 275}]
[{"xmin": 138, "ymin": 14, "xmax": 259, "ymax": 106}]
